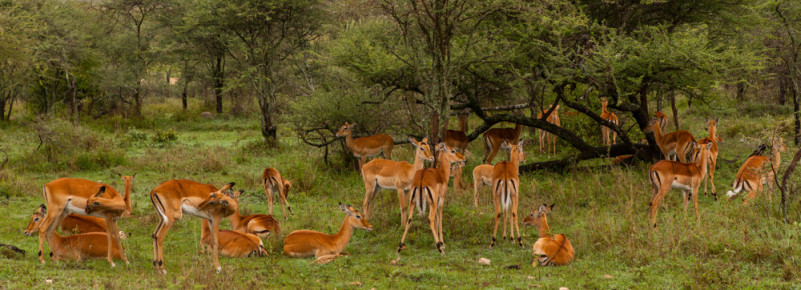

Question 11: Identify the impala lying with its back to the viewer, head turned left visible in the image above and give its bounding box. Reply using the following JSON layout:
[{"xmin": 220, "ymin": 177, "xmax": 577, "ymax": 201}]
[{"xmin": 523, "ymin": 204, "xmax": 575, "ymax": 267}]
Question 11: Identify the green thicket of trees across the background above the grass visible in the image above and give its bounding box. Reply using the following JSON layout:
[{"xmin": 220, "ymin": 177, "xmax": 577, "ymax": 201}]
[{"xmin": 0, "ymin": 0, "xmax": 801, "ymax": 163}]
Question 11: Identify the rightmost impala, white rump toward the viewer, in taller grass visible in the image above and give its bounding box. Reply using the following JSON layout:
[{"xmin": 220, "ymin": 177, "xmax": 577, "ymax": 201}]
[{"xmin": 726, "ymin": 138, "xmax": 787, "ymax": 204}]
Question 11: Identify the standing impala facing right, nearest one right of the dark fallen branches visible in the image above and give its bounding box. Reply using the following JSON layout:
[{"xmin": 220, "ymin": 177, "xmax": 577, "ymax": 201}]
[{"xmin": 648, "ymin": 142, "xmax": 712, "ymax": 227}]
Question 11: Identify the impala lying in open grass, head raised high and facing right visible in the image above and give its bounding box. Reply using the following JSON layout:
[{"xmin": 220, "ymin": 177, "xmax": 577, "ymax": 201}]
[{"xmin": 284, "ymin": 203, "xmax": 373, "ymax": 264}]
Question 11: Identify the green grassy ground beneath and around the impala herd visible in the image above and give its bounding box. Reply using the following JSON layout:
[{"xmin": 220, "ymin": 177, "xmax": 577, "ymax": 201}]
[{"xmin": 0, "ymin": 101, "xmax": 801, "ymax": 289}]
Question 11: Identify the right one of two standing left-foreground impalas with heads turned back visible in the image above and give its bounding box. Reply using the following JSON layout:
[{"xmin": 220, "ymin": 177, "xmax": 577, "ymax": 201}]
[{"xmin": 150, "ymin": 179, "xmax": 239, "ymax": 274}]
